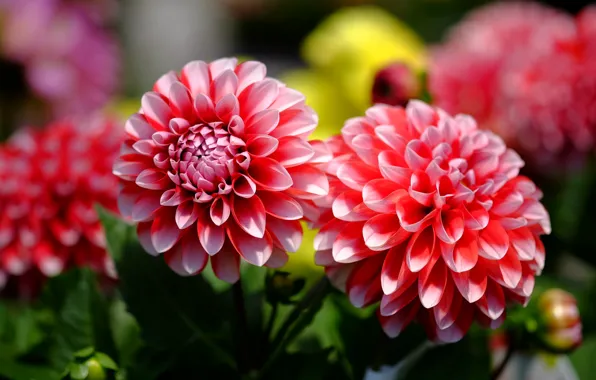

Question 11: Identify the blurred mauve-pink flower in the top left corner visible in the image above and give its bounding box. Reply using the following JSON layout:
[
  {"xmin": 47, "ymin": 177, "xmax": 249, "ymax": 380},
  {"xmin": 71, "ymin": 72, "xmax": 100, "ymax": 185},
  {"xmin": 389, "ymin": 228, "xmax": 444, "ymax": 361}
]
[{"xmin": 0, "ymin": 0, "xmax": 120, "ymax": 116}]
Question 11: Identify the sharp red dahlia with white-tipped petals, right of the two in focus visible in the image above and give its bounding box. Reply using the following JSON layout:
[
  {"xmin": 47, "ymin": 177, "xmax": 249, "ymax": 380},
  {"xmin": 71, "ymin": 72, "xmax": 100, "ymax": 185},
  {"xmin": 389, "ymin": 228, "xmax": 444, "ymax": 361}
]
[{"xmin": 315, "ymin": 101, "xmax": 550, "ymax": 342}]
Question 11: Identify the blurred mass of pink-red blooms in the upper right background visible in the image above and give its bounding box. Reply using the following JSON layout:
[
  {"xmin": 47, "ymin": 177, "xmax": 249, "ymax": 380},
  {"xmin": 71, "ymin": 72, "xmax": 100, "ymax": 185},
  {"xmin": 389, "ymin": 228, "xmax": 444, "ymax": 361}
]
[{"xmin": 429, "ymin": 3, "xmax": 596, "ymax": 169}]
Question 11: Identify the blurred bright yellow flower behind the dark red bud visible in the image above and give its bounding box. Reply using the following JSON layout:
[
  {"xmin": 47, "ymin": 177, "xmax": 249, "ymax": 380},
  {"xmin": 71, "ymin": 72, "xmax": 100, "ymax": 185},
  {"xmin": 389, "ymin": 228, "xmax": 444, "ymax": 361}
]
[{"xmin": 302, "ymin": 6, "xmax": 426, "ymax": 116}]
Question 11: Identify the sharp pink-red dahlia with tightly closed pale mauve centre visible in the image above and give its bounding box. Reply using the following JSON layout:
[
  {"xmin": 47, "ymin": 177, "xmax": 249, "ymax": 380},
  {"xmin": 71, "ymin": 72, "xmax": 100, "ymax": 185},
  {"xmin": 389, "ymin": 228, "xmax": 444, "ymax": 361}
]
[{"xmin": 114, "ymin": 59, "xmax": 330, "ymax": 282}]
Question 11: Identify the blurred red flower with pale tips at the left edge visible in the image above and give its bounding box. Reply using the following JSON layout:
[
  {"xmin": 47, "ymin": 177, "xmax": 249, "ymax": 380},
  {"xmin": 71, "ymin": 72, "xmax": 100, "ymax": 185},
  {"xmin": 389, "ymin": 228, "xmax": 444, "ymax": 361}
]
[{"xmin": 0, "ymin": 118, "xmax": 122, "ymax": 293}]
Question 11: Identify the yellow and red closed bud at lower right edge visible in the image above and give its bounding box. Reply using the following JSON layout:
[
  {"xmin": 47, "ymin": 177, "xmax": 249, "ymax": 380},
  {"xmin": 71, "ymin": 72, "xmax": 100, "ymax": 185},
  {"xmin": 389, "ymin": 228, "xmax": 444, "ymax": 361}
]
[{"xmin": 538, "ymin": 289, "xmax": 582, "ymax": 353}]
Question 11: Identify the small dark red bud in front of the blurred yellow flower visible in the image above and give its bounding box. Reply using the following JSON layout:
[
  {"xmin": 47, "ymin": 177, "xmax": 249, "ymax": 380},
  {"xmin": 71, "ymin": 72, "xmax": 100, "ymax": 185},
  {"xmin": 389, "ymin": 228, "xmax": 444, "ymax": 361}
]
[{"xmin": 372, "ymin": 62, "xmax": 421, "ymax": 106}]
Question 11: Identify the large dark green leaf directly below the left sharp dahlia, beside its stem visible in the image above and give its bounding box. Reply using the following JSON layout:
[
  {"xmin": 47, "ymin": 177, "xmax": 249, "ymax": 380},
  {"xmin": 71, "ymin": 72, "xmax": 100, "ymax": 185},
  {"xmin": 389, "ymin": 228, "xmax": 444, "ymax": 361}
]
[{"xmin": 99, "ymin": 214, "xmax": 235, "ymax": 372}]
